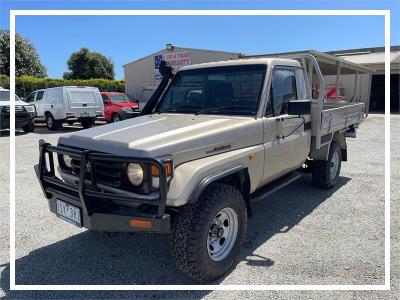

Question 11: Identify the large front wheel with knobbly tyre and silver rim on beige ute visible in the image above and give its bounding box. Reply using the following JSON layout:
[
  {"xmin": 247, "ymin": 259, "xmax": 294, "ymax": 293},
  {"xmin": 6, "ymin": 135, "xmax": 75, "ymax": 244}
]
[{"xmin": 172, "ymin": 183, "xmax": 247, "ymax": 281}]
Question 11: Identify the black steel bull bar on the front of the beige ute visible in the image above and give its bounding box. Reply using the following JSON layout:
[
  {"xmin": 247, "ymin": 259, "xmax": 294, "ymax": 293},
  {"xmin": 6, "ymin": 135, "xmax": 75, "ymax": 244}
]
[{"xmin": 35, "ymin": 140, "xmax": 171, "ymax": 232}]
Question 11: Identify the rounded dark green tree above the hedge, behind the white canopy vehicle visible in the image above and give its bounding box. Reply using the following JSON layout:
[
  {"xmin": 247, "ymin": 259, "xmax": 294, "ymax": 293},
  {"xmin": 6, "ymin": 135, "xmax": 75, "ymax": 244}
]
[{"xmin": 63, "ymin": 48, "xmax": 115, "ymax": 79}]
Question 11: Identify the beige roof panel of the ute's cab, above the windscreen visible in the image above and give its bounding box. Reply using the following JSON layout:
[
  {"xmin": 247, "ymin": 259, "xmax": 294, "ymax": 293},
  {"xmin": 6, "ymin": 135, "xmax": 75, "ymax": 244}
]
[{"xmin": 179, "ymin": 58, "xmax": 301, "ymax": 71}]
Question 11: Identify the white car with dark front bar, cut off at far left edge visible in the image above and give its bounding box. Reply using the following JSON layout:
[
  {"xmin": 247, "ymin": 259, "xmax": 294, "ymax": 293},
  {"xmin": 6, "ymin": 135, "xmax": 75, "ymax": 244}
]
[{"xmin": 0, "ymin": 87, "xmax": 36, "ymax": 132}]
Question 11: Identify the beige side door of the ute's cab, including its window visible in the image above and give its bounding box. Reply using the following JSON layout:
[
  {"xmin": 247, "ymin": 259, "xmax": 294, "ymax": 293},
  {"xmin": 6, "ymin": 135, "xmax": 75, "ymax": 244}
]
[{"xmin": 263, "ymin": 66, "xmax": 311, "ymax": 183}]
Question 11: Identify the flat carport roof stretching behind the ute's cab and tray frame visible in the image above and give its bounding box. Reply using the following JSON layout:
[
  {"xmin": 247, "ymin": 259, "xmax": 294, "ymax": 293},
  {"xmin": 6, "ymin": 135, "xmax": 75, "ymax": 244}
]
[{"xmin": 242, "ymin": 50, "xmax": 375, "ymax": 75}]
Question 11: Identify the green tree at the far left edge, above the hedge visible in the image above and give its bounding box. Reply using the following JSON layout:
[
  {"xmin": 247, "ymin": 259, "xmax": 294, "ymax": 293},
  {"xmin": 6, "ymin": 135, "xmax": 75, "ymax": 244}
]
[{"xmin": 0, "ymin": 30, "xmax": 47, "ymax": 77}]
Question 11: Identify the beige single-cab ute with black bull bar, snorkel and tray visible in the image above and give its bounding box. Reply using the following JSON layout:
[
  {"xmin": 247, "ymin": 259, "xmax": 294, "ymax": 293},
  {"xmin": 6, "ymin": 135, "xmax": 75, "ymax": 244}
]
[{"xmin": 35, "ymin": 53, "xmax": 369, "ymax": 281}]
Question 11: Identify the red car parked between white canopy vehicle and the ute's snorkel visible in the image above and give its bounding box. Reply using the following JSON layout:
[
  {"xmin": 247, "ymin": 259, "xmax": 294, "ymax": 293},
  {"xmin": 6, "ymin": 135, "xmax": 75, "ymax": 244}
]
[{"xmin": 101, "ymin": 92, "xmax": 139, "ymax": 122}]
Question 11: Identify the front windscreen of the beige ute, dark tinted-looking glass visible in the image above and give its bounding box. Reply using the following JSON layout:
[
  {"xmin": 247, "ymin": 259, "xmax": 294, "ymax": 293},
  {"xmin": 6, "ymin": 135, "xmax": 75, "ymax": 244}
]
[{"xmin": 156, "ymin": 65, "xmax": 266, "ymax": 116}]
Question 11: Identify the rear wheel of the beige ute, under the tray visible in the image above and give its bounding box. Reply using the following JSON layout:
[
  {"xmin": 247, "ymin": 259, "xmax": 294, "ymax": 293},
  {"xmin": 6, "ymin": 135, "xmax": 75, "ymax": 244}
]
[{"xmin": 312, "ymin": 142, "xmax": 342, "ymax": 189}]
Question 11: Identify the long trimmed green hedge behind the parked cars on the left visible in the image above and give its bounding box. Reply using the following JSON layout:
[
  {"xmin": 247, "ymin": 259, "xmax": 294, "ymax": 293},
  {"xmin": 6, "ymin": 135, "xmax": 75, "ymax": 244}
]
[{"xmin": 0, "ymin": 75, "xmax": 125, "ymax": 98}]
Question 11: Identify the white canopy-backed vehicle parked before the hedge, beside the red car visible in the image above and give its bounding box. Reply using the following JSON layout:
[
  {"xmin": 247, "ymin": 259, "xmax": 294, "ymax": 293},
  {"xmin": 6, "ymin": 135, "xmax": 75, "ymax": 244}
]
[{"xmin": 25, "ymin": 86, "xmax": 104, "ymax": 130}]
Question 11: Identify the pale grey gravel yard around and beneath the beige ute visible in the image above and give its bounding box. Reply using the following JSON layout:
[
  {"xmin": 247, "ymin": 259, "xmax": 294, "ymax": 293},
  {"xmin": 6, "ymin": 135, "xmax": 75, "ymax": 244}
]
[{"xmin": 0, "ymin": 115, "xmax": 400, "ymax": 299}]
